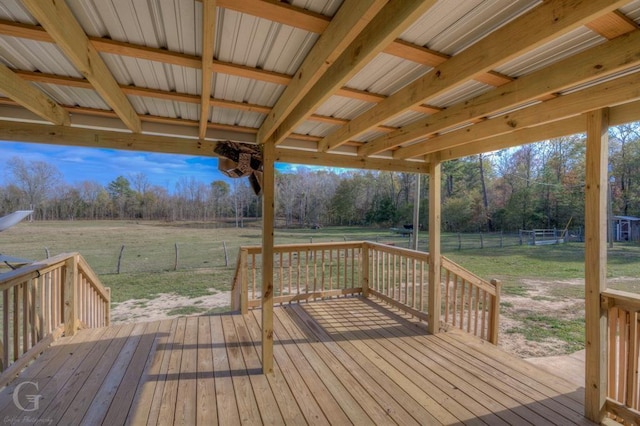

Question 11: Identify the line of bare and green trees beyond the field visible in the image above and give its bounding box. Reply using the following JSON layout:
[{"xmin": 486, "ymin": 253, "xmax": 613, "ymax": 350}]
[{"xmin": 0, "ymin": 123, "xmax": 640, "ymax": 232}]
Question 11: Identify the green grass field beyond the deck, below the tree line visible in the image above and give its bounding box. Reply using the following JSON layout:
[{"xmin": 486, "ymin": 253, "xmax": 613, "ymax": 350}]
[{"xmin": 0, "ymin": 221, "xmax": 640, "ymax": 303}]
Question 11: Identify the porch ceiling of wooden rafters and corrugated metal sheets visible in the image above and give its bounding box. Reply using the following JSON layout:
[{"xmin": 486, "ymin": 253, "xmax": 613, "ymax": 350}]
[{"xmin": 0, "ymin": 0, "xmax": 640, "ymax": 172}]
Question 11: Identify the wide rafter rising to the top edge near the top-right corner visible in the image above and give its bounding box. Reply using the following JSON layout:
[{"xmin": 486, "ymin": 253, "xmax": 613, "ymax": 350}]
[{"xmin": 321, "ymin": 0, "xmax": 626, "ymax": 150}]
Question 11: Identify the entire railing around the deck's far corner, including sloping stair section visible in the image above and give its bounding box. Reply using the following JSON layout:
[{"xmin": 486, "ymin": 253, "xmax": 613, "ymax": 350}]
[{"xmin": 231, "ymin": 242, "xmax": 500, "ymax": 344}]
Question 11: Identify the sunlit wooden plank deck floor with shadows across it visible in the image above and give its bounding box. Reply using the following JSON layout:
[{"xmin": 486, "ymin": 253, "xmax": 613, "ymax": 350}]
[{"xmin": 0, "ymin": 297, "xmax": 591, "ymax": 425}]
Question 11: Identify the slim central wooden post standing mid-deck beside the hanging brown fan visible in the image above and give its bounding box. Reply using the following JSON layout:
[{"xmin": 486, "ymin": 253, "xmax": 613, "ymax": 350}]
[{"xmin": 262, "ymin": 143, "xmax": 276, "ymax": 374}]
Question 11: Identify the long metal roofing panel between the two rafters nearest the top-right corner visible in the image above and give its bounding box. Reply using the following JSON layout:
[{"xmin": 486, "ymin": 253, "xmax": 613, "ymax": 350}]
[{"xmin": 496, "ymin": 27, "xmax": 606, "ymax": 77}]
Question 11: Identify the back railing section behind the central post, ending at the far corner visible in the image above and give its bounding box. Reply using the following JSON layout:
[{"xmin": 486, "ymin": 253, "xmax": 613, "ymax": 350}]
[{"xmin": 231, "ymin": 243, "xmax": 362, "ymax": 312}]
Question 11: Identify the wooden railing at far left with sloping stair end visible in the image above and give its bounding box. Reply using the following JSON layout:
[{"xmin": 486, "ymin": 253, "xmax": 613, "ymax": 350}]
[{"xmin": 0, "ymin": 253, "xmax": 110, "ymax": 387}]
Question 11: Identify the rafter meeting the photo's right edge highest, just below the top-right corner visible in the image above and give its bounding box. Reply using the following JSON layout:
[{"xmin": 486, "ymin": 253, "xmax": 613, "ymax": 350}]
[{"xmin": 358, "ymin": 31, "xmax": 640, "ymax": 156}]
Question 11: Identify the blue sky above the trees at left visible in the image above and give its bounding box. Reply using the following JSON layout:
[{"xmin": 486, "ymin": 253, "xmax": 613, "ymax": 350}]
[{"xmin": 0, "ymin": 141, "xmax": 324, "ymax": 192}]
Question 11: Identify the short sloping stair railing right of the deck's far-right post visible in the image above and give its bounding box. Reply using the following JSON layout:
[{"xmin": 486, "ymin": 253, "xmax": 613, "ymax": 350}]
[{"xmin": 441, "ymin": 256, "xmax": 501, "ymax": 345}]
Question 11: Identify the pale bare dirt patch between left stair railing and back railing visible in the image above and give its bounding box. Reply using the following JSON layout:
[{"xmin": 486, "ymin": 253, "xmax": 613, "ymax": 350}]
[{"xmin": 111, "ymin": 289, "xmax": 231, "ymax": 324}]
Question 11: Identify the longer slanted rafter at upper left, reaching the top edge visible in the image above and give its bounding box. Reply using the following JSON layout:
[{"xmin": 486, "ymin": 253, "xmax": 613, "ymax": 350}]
[{"xmin": 22, "ymin": 0, "xmax": 140, "ymax": 133}]
